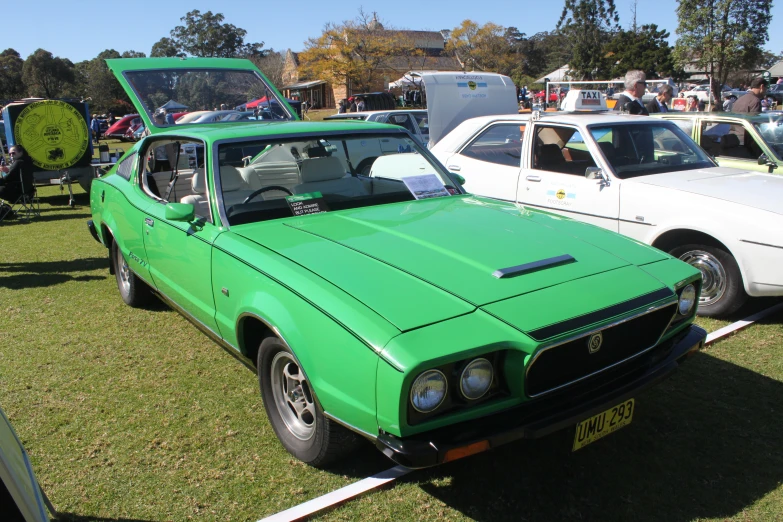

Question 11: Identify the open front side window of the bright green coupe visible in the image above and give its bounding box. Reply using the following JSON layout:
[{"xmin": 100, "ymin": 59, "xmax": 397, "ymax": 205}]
[{"xmin": 140, "ymin": 139, "xmax": 212, "ymax": 222}]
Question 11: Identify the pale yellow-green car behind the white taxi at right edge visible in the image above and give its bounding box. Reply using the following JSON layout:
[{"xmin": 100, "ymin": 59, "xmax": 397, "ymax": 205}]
[{"xmin": 652, "ymin": 111, "xmax": 783, "ymax": 174}]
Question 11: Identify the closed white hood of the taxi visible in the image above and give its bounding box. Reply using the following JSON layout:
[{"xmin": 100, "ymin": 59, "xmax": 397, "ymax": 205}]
[{"xmin": 623, "ymin": 167, "xmax": 783, "ymax": 214}]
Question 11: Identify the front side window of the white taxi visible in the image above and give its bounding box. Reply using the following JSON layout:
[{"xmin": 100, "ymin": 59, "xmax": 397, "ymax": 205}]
[{"xmin": 533, "ymin": 126, "xmax": 595, "ymax": 176}]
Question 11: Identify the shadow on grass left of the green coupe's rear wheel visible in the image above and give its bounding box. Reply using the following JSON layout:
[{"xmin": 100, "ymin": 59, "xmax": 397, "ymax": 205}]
[{"xmin": 0, "ymin": 257, "xmax": 109, "ymax": 290}]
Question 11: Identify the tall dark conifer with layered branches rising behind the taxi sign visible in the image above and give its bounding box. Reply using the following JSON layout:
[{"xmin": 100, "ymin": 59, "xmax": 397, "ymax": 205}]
[{"xmin": 557, "ymin": 0, "xmax": 620, "ymax": 80}]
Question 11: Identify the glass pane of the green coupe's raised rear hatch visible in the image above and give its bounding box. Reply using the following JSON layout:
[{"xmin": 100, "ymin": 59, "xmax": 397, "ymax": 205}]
[{"xmin": 124, "ymin": 69, "xmax": 296, "ymax": 127}]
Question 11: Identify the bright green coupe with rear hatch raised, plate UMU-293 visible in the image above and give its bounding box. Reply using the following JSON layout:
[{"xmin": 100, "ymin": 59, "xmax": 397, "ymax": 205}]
[{"xmin": 89, "ymin": 58, "xmax": 705, "ymax": 467}]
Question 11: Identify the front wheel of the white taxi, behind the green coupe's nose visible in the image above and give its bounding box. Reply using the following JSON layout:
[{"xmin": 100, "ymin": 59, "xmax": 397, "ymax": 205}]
[{"xmin": 669, "ymin": 243, "xmax": 748, "ymax": 317}]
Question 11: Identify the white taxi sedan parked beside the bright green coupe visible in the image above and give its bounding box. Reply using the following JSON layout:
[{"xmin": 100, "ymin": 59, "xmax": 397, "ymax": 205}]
[{"xmin": 431, "ymin": 103, "xmax": 783, "ymax": 316}]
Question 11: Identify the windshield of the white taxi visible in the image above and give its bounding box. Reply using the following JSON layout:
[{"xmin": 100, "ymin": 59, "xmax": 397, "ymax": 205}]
[{"xmin": 589, "ymin": 121, "xmax": 716, "ymax": 179}]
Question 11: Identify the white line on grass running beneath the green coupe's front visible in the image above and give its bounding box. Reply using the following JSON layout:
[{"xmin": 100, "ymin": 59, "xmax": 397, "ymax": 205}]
[{"xmin": 258, "ymin": 303, "xmax": 783, "ymax": 522}]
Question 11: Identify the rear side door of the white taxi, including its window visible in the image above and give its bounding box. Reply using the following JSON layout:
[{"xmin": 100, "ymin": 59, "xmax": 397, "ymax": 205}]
[{"xmin": 445, "ymin": 122, "xmax": 525, "ymax": 201}]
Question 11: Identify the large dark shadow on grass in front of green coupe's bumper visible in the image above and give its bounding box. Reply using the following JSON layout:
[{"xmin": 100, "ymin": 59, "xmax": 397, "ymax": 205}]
[{"xmin": 414, "ymin": 353, "xmax": 783, "ymax": 522}]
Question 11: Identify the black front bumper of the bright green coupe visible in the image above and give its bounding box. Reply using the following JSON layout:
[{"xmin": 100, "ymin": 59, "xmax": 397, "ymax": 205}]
[{"xmin": 375, "ymin": 325, "xmax": 707, "ymax": 468}]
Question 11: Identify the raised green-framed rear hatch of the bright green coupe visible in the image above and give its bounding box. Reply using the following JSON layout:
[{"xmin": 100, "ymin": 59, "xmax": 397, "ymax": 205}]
[{"xmin": 106, "ymin": 58, "xmax": 298, "ymax": 134}]
